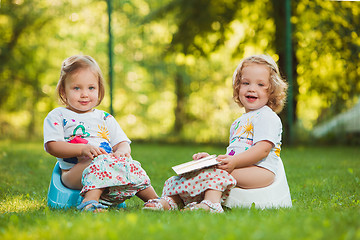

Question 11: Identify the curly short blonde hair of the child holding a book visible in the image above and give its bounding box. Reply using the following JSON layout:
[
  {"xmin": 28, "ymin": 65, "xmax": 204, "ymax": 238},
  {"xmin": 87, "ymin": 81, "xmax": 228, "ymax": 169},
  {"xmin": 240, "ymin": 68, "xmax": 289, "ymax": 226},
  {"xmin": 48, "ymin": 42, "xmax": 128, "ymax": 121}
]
[{"xmin": 233, "ymin": 54, "xmax": 288, "ymax": 113}]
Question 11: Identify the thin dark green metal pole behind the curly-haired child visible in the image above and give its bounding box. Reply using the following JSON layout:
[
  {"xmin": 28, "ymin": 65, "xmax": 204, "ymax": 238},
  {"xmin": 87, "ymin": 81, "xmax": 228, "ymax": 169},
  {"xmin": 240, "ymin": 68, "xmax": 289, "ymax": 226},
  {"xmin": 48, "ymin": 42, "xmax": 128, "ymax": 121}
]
[{"xmin": 285, "ymin": 0, "xmax": 294, "ymax": 144}]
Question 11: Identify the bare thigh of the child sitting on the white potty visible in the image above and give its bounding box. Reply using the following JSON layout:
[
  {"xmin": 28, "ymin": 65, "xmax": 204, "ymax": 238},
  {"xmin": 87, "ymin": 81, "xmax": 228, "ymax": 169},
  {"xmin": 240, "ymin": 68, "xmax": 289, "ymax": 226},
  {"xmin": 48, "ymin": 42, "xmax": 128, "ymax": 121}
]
[{"xmin": 231, "ymin": 166, "xmax": 275, "ymax": 189}]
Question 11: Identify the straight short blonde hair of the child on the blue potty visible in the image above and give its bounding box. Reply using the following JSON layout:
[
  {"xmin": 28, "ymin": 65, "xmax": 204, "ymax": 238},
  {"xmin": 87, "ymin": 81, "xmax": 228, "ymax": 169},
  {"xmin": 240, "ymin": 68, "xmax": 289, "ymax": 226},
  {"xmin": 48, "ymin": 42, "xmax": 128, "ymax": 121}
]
[{"xmin": 56, "ymin": 55, "xmax": 105, "ymax": 105}]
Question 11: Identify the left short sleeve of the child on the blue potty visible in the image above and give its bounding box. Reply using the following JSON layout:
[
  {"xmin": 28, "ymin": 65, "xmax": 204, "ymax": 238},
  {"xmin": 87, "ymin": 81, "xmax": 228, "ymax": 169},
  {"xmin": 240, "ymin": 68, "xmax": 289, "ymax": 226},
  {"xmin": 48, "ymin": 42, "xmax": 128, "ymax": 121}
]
[{"xmin": 44, "ymin": 109, "xmax": 65, "ymax": 144}]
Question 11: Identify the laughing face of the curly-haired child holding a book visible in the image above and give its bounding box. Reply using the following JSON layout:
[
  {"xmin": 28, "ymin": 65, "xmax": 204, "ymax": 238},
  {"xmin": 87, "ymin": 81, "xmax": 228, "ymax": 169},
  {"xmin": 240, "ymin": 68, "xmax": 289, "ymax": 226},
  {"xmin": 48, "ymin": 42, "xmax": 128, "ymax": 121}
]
[{"xmin": 239, "ymin": 63, "xmax": 270, "ymax": 112}]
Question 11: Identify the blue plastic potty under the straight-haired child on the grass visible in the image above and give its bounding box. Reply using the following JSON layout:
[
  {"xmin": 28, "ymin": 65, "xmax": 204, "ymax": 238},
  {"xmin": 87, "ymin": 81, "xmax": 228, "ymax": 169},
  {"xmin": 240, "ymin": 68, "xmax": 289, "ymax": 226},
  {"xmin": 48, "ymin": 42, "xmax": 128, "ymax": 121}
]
[{"xmin": 48, "ymin": 162, "xmax": 126, "ymax": 209}]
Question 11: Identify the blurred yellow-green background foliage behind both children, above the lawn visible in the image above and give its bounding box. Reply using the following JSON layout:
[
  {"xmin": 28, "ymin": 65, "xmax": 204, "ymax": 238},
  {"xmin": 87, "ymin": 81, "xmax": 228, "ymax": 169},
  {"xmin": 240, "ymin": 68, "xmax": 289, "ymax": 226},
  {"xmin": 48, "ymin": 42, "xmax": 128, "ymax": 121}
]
[{"xmin": 0, "ymin": 0, "xmax": 360, "ymax": 142}]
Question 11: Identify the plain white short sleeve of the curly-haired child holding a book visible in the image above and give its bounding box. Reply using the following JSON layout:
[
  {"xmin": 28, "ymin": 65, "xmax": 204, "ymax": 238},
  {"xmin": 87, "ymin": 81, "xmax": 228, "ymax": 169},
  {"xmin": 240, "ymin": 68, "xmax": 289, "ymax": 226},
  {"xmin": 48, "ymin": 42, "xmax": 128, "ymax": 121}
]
[{"xmin": 253, "ymin": 111, "xmax": 282, "ymax": 146}]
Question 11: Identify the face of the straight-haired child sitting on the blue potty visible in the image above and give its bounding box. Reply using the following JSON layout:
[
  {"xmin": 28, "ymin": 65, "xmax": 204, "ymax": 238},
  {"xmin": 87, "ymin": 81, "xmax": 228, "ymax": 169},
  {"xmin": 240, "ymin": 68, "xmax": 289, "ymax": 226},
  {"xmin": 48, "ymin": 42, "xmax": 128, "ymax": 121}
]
[{"xmin": 65, "ymin": 69, "xmax": 99, "ymax": 113}]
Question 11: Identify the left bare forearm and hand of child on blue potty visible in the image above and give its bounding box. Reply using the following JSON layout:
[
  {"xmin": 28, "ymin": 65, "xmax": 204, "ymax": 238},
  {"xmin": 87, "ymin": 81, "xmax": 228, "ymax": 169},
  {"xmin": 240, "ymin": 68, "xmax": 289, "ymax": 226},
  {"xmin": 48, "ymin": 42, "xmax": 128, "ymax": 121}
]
[{"xmin": 45, "ymin": 141, "xmax": 107, "ymax": 159}]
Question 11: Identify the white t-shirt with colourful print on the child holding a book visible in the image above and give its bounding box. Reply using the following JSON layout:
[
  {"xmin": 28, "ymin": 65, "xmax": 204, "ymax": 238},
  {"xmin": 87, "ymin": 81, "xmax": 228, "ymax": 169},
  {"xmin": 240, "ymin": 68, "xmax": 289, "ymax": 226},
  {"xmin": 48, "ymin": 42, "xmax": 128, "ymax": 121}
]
[{"xmin": 226, "ymin": 106, "xmax": 282, "ymax": 174}]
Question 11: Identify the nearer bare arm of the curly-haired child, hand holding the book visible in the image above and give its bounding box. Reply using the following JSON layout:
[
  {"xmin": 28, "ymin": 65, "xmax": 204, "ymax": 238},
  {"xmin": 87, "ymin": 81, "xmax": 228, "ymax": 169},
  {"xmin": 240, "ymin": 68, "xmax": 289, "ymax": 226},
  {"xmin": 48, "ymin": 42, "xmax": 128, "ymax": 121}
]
[{"xmin": 217, "ymin": 141, "xmax": 273, "ymax": 173}]
